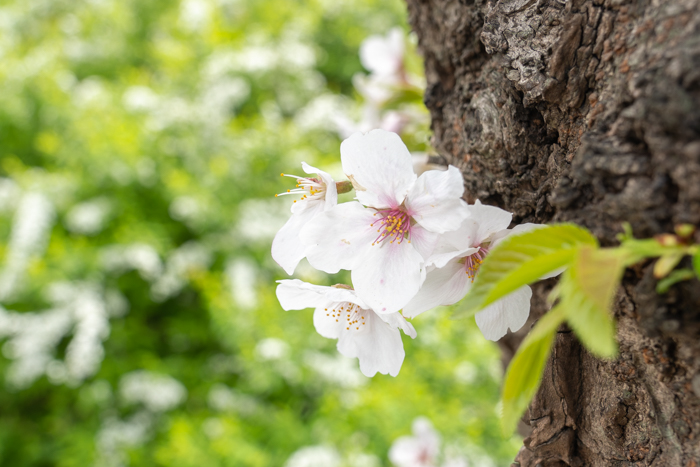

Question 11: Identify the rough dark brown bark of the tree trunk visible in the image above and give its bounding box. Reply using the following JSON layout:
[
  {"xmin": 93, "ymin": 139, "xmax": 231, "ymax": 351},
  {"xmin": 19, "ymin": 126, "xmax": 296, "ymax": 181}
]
[{"xmin": 407, "ymin": 0, "xmax": 700, "ymax": 467}]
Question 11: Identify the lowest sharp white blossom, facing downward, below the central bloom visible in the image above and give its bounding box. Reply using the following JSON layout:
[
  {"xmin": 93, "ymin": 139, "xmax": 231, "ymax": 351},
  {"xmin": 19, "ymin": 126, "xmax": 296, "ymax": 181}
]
[{"xmin": 277, "ymin": 279, "xmax": 416, "ymax": 377}]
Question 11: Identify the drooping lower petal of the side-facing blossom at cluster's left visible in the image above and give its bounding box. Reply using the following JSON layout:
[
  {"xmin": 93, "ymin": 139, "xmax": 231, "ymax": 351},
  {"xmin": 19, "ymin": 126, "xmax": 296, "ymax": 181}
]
[{"xmin": 271, "ymin": 203, "xmax": 323, "ymax": 275}]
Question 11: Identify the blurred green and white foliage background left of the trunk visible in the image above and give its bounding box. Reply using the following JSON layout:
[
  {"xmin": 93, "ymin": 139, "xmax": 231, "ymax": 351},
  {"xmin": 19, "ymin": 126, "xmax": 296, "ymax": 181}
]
[{"xmin": 0, "ymin": 0, "xmax": 520, "ymax": 467}]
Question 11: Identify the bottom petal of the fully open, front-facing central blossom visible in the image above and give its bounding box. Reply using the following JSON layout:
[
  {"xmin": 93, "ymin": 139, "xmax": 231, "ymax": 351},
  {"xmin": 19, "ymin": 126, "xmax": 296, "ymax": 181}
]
[{"xmin": 351, "ymin": 241, "xmax": 425, "ymax": 313}]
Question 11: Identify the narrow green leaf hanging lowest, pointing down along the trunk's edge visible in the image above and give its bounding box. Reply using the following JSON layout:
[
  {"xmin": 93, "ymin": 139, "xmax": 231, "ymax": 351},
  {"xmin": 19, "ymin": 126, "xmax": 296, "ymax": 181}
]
[{"xmin": 501, "ymin": 307, "xmax": 564, "ymax": 436}]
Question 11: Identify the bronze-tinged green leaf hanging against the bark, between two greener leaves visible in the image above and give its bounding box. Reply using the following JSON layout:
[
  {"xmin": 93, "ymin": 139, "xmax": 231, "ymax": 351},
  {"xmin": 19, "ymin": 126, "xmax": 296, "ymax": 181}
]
[{"xmin": 559, "ymin": 247, "xmax": 626, "ymax": 358}]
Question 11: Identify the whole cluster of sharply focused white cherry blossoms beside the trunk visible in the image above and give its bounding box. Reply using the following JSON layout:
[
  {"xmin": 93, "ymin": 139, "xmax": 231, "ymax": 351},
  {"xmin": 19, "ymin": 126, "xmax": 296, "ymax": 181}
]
[{"xmin": 272, "ymin": 129, "xmax": 533, "ymax": 376}]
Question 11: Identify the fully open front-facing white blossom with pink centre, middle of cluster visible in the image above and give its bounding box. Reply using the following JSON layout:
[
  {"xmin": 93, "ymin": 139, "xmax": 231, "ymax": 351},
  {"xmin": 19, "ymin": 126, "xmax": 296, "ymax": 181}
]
[{"xmin": 301, "ymin": 130, "xmax": 469, "ymax": 313}]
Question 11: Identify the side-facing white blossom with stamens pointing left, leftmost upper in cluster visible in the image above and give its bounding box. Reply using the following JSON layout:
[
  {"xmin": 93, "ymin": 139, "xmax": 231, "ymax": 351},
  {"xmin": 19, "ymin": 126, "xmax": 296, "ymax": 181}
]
[{"xmin": 272, "ymin": 162, "xmax": 338, "ymax": 275}]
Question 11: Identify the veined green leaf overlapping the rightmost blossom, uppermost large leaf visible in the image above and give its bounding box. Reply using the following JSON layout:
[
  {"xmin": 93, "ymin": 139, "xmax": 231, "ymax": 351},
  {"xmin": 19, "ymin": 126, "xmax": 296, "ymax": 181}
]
[{"xmin": 455, "ymin": 224, "xmax": 598, "ymax": 317}]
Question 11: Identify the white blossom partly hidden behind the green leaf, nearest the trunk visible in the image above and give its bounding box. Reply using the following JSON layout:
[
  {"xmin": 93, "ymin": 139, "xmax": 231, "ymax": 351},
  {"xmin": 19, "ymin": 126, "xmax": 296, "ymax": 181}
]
[{"xmin": 403, "ymin": 201, "xmax": 537, "ymax": 341}]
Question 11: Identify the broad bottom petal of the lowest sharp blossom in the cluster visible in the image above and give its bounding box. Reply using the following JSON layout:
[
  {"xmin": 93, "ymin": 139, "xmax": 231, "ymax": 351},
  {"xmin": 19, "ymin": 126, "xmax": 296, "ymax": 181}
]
[{"xmin": 338, "ymin": 312, "xmax": 405, "ymax": 377}]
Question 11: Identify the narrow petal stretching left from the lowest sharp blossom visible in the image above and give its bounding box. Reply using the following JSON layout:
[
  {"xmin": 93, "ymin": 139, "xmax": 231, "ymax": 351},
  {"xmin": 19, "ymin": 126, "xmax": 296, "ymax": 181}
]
[{"xmin": 277, "ymin": 279, "xmax": 367, "ymax": 310}]
